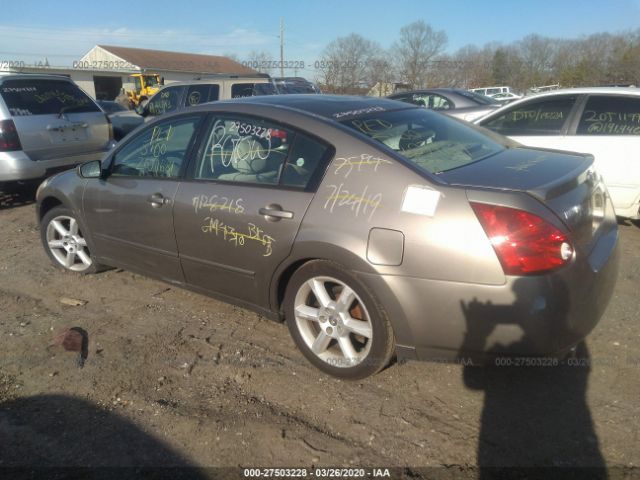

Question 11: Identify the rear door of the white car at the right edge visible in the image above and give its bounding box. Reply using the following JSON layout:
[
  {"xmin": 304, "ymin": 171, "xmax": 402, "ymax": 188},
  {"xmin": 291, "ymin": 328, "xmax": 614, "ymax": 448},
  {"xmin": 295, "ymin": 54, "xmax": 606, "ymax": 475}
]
[{"xmin": 564, "ymin": 95, "xmax": 640, "ymax": 213}]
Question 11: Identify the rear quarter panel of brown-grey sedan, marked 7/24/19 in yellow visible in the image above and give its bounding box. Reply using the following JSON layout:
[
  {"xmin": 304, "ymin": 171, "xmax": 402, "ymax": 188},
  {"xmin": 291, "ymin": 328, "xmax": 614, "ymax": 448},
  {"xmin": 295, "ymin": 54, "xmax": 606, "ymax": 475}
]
[{"xmin": 274, "ymin": 123, "xmax": 505, "ymax": 345}]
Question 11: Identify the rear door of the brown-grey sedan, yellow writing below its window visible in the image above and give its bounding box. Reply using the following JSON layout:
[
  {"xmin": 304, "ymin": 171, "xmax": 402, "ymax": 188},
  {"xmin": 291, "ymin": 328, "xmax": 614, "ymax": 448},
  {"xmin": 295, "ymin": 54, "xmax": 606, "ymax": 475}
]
[{"xmin": 174, "ymin": 114, "xmax": 333, "ymax": 306}]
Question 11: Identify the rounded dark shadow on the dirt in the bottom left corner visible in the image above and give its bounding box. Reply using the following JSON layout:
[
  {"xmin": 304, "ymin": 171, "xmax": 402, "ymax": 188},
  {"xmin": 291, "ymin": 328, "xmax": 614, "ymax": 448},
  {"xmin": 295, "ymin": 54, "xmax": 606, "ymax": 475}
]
[{"xmin": 0, "ymin": 395, "xmax": 206, "ymax": 478}]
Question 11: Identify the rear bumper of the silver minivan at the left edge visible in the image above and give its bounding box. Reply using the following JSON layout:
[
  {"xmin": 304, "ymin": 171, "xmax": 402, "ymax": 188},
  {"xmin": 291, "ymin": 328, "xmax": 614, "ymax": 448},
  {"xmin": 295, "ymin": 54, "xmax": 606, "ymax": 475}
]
[{"xmin": 0, "ymin": 150, "xmax": 108, "ymax": 182}]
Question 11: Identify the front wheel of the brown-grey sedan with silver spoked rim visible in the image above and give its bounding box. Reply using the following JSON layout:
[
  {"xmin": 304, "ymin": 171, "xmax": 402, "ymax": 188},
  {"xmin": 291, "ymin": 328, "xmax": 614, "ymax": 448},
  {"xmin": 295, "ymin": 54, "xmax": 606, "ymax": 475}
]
[{"xmin": 40, "ymin": 207, "xmax": 100, "ymax": 273}]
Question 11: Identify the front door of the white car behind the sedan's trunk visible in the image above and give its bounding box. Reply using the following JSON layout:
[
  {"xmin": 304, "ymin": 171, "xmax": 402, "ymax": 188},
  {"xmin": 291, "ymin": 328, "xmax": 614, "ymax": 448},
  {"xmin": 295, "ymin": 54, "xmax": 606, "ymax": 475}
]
[{"xmin": 480, "ymin": 94, "xmax": 579, "ymax": 150}]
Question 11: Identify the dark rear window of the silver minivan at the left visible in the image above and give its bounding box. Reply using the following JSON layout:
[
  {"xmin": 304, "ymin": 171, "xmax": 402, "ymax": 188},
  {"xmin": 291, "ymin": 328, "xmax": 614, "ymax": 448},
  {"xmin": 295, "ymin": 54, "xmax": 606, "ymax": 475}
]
[{"xmin": 0, "ymin": 78, "xmax": 100, "ymax": 117}]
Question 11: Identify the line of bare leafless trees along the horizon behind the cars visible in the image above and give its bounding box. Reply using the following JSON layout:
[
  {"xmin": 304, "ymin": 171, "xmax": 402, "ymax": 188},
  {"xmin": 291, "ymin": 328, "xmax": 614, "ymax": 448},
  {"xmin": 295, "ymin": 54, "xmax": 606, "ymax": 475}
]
[{"xmin": 319, "ymin": 26, "xmax": 640, "ymax": 93}]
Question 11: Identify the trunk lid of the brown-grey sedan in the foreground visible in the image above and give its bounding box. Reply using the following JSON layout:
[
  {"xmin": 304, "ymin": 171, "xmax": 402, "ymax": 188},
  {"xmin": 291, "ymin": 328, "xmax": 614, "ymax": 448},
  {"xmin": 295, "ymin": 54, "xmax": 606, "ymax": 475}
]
[{"xmin": 438, "ymin": 148, "xmax": 610, "ymax": 253}]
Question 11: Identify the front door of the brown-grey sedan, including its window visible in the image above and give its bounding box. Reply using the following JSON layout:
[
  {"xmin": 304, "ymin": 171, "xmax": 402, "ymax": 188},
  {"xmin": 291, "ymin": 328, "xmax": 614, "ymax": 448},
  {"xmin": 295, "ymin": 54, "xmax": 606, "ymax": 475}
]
[{"xmin": 83, "ymin": 114, "xmax": 204, "ymax": 282}]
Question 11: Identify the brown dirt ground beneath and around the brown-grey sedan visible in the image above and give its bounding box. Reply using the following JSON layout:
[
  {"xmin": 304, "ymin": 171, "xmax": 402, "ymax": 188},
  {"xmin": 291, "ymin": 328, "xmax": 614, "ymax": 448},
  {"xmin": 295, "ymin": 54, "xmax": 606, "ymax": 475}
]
[{"xmin": 0, "ymin": 184, "xmax": 640, "ymax": 478}]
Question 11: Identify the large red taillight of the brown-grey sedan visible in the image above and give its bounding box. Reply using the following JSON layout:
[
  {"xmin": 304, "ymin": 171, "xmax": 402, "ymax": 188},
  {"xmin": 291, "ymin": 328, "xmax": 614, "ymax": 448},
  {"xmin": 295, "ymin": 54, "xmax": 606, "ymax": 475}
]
[{"xmin": 471, "ymin": 202, "xmax": 573, "ymax": 275}]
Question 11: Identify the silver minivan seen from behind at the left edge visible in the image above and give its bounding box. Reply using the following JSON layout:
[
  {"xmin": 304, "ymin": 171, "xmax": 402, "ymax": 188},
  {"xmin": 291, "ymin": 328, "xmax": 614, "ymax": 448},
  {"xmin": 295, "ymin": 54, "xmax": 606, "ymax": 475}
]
[{"xmin": 0, "ymin": 75, "xmax": 113, "ymax": 184}]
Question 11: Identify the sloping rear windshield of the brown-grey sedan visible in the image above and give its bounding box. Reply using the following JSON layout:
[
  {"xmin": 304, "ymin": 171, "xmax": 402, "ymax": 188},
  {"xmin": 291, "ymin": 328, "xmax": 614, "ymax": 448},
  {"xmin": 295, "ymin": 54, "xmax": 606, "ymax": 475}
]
[{"xmin": 342, "ymin": 108, "xmax": 505, "ymax": 174}]
